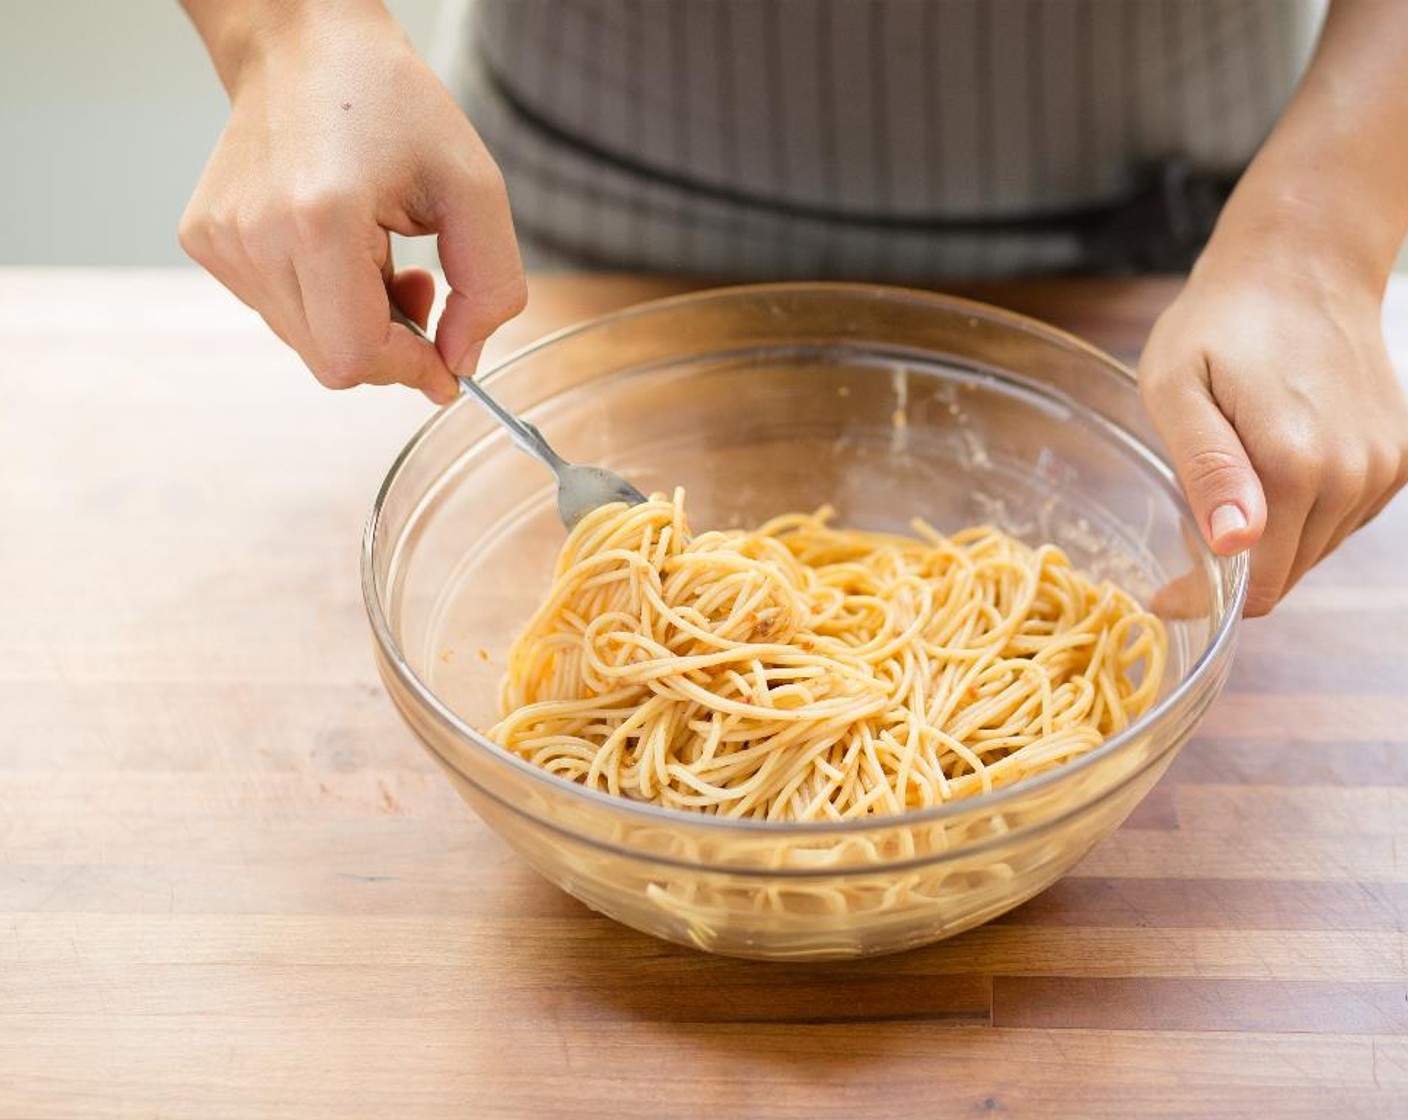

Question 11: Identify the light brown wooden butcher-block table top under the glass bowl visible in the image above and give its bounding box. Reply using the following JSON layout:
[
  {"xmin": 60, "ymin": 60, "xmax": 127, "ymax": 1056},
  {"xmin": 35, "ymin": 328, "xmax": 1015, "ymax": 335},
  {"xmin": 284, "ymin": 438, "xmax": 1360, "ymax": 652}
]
[{"xmin": 0, "ymin": 270, "xmax": 1408, "ymax": 1120}]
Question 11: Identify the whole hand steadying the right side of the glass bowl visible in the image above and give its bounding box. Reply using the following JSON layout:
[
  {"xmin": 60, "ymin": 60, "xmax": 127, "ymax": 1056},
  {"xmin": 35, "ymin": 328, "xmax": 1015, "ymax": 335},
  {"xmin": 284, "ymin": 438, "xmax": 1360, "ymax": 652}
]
[{"xmin": 1139, "ymin": 254, "xmax": 1408, "ymax": 616}]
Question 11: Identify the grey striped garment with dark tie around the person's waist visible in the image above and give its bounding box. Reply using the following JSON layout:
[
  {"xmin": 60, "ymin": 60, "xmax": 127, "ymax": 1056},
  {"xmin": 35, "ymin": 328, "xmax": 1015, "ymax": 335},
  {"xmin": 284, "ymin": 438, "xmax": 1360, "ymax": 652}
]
[{"xmin": 444, "ymin": 0, "xmax": 1324, "ymax": 278}]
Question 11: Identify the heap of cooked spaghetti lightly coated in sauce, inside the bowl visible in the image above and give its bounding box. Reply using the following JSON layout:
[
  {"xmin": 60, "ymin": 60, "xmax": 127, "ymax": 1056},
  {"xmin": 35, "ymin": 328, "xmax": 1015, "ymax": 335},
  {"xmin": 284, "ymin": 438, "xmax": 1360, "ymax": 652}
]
[{"xmin": 489, "ymin": 490, "xmax": 1167, "ymax": 821}]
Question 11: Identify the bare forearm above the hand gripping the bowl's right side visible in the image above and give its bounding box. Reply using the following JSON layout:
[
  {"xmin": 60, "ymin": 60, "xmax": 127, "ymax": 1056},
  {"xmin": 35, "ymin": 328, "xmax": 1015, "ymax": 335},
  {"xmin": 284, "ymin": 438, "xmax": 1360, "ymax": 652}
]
[{"xmin": 1209, "ymin": 0, "xmax": 1408, "ymax": 289}]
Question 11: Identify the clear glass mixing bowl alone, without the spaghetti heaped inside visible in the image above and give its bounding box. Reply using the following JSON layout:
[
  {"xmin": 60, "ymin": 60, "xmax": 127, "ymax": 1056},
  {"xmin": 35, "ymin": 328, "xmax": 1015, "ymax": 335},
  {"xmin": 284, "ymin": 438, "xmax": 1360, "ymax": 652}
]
[{"xmin": 362, "ymin": 283, "xmax": 1246, "ymax": 959}]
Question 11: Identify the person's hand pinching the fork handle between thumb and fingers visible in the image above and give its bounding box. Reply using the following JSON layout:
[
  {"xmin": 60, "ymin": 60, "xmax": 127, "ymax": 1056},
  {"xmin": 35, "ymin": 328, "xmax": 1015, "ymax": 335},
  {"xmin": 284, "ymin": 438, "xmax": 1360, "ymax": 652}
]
[{"xmin": 180, "ymin": 4, "xmax": 525, "ymax": 403}]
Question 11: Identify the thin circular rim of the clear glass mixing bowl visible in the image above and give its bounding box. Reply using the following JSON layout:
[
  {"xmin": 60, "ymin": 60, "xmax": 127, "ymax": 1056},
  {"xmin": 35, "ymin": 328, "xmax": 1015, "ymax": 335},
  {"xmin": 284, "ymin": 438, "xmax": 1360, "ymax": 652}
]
[{"xmin": 362, "ymin": 280, "xmax": 1247, "ymax": 838}]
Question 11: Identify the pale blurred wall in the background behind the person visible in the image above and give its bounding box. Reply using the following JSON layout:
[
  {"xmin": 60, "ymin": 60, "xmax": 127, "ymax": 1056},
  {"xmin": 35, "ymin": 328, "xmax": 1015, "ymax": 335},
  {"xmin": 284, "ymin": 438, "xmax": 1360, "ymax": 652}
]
[{"xmin": 0, "ymin": 0, "xmax": 1408, "ymax": 268}]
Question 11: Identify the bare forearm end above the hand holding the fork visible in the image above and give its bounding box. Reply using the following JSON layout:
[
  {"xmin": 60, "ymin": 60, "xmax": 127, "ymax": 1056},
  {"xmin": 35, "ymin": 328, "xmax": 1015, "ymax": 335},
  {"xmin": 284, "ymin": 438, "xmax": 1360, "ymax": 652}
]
[{"xmin": 180, "ymin": 0, "xmax": 396, "ymax": 96}]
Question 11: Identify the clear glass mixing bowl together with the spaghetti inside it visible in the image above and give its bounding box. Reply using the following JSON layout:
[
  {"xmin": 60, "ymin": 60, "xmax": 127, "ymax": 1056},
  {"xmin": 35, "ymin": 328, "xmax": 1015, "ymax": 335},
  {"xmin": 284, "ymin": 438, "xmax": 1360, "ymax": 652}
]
[{"xmin": 363, "ymin": 285, "xmax": 1246, "ymax": 959}]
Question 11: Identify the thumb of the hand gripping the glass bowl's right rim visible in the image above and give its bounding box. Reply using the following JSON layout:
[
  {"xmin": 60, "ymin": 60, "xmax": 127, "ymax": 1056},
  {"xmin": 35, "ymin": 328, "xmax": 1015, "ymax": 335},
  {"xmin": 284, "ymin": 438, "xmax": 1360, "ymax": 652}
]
[{"xmin": 1140, "ymin": 369, "xmax": 1266, "ymax": 556}]
